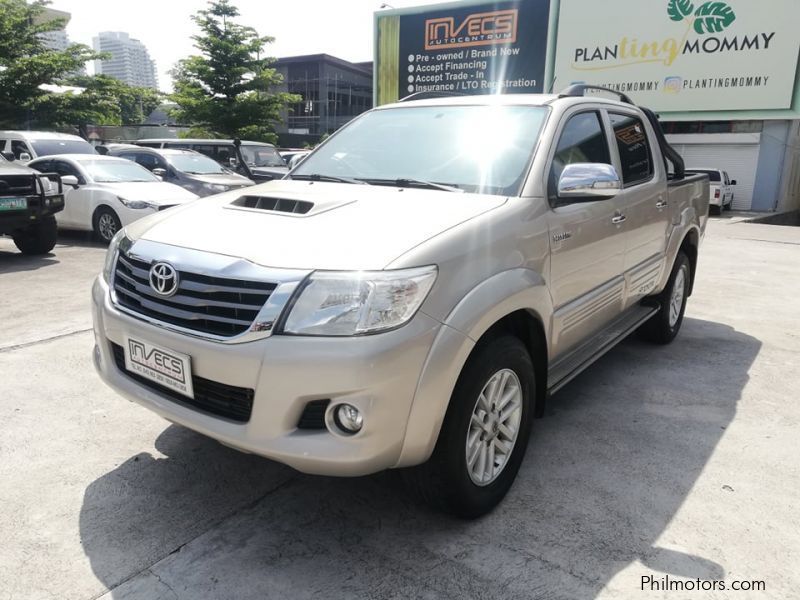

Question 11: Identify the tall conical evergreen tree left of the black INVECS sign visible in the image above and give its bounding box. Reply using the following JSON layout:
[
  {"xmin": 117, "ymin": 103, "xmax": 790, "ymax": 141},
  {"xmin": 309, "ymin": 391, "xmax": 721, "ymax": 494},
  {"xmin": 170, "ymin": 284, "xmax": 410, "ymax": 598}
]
[{"xmin": 171, "ymin": 0, "xmax": 300, "ymax": 142}]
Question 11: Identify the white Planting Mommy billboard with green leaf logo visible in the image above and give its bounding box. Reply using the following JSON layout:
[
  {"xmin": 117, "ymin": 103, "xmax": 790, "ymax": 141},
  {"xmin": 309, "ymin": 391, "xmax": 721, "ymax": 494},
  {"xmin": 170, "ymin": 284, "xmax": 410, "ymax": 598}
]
[{"xmin": 555, "ymin": 0, "xmax": 800, "ymax": 112}]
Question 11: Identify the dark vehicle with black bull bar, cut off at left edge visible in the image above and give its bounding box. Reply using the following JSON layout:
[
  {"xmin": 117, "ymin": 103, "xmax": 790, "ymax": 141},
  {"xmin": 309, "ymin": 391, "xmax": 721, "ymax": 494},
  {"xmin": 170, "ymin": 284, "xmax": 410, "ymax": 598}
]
[{"xmin": 0, "ymin": 155, "xmax": 64, "ymax": 254}]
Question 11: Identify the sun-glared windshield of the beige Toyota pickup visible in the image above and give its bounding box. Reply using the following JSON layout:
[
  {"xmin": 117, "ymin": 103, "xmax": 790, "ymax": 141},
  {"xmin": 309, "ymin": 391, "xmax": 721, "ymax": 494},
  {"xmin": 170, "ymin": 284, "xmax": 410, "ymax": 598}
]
[{"xmin": 292, "ymin": 105, "xmax": 548, "ymax": 195}]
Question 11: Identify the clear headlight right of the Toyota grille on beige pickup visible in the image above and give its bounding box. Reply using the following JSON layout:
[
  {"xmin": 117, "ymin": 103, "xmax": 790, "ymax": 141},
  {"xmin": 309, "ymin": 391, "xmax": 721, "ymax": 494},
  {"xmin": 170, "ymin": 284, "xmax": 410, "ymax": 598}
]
[{"xmin": 283, "ymin": 266, "xmax": 437, "ymax": 336}]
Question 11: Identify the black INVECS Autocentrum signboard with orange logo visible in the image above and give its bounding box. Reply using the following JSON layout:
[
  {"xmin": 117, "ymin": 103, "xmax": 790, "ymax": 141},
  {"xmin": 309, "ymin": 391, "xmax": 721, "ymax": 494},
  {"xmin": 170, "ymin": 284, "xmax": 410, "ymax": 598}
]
[{"xmin": 375, "ymin": 0, "xmax": 550, "ymax": 104}]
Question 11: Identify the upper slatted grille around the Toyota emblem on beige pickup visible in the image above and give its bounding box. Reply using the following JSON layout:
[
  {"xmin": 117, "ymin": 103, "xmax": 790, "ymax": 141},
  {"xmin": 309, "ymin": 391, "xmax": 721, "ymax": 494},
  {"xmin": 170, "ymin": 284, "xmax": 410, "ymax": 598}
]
[{"xmin": 114, "ymin": 252, "xmax": 276, "ymax": 337}]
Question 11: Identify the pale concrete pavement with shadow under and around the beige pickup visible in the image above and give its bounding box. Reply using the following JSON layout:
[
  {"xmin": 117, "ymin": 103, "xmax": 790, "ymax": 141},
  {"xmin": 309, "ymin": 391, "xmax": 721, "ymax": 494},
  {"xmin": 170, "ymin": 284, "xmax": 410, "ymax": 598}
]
[{"xmin": 0, "ymin": 218, "xmax": 800, "ymax": 600}]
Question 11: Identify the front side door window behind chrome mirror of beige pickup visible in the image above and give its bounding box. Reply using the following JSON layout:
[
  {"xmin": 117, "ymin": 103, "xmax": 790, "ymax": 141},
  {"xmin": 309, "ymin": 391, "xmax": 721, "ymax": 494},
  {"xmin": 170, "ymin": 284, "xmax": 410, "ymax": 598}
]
[{"xmin": 547, "ymin": 112, "xmax": 611, "ymax": 198}]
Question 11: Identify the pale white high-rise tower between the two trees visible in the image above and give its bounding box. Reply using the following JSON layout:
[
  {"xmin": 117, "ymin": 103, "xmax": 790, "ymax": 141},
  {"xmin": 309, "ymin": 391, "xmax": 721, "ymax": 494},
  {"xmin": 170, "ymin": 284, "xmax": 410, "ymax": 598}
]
[{"xmin": 92, "ymin": 31, "xmax": 158, "ymax": 89}]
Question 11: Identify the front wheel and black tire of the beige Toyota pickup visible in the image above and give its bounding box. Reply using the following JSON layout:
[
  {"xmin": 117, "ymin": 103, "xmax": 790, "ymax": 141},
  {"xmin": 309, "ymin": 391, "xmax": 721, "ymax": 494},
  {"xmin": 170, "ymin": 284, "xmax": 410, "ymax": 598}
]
[{"xmin": 405, "ymin": 335, "xmax": 536, "ymax": 518}]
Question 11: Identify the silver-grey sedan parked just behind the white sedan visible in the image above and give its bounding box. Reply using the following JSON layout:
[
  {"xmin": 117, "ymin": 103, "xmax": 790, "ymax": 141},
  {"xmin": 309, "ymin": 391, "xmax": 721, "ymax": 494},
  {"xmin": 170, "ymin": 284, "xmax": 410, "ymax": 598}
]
[{"xmin": 108, "ymin": 146, "xmax": 253, "ymax": 196}]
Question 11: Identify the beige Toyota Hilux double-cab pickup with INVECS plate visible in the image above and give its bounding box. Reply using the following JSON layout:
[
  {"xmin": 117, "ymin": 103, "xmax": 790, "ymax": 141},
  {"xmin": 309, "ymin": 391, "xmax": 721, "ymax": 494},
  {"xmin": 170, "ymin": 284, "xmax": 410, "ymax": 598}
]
[{"xmin": 92, "ymin": 86, "xmax": 708, "ymax": 517}]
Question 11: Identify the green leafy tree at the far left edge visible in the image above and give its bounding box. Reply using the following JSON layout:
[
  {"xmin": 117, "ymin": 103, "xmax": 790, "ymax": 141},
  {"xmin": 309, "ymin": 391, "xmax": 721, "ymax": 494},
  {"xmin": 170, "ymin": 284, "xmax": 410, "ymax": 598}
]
[{"xmin": 0, "ymin": 0, "xmax": 103, "ymax": 128}]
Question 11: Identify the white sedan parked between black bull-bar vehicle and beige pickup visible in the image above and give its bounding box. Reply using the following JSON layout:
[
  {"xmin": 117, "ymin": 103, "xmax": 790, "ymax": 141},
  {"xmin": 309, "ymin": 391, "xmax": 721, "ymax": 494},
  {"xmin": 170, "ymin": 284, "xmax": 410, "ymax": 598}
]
[{"xmin": 30, "ymin": 154, "xmax": 197, "ymax": 242}]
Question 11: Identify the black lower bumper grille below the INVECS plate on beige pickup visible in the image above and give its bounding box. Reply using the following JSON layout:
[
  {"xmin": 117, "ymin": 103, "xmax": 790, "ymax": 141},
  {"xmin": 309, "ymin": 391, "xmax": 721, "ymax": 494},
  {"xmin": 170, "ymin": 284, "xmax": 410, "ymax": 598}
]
[{"xmin": 111, "ymin": 342, "xmax": 255, "ymax": 423}]
